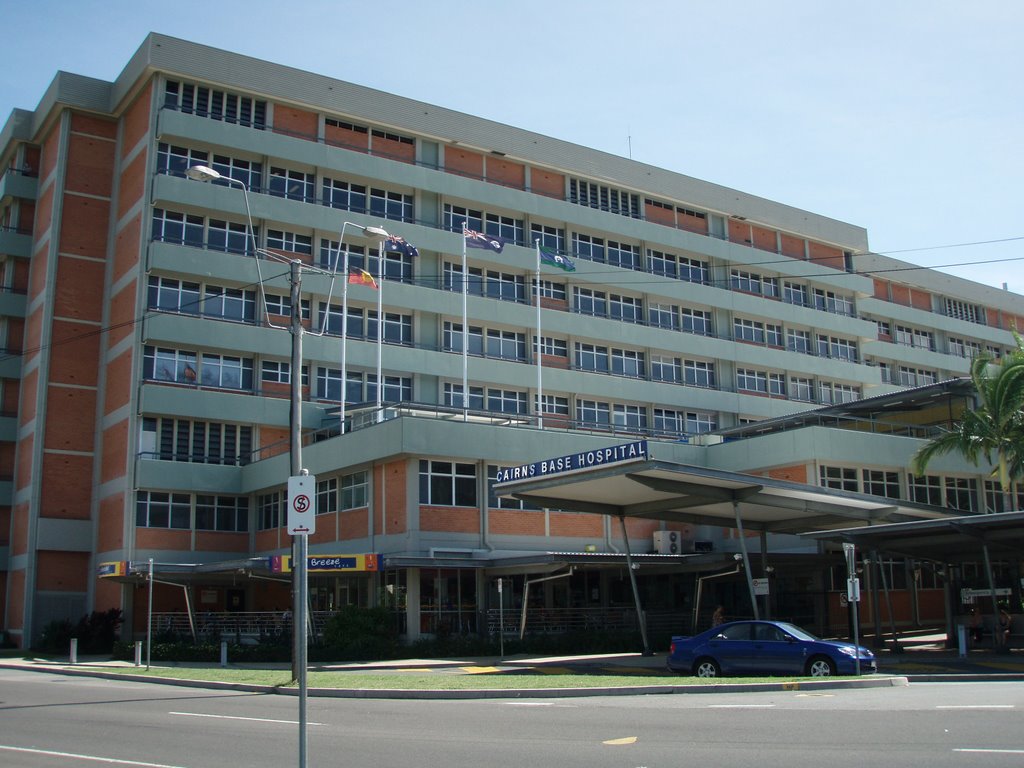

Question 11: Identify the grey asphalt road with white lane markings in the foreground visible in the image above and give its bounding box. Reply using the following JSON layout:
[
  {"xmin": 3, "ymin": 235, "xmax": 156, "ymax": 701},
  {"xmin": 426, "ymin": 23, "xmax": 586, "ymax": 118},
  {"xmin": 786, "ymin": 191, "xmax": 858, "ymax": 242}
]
[{"xmin": 0, "ymin": 670, "xmax": 1024, "ymax": 768}]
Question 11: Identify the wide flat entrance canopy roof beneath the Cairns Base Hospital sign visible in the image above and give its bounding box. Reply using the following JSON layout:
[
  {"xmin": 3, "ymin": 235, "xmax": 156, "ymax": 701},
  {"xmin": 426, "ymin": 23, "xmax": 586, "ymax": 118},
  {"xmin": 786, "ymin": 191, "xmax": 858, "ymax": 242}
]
[{"xmin": 495, "ymin": 459, "xmax": 955, "ymax": 534}]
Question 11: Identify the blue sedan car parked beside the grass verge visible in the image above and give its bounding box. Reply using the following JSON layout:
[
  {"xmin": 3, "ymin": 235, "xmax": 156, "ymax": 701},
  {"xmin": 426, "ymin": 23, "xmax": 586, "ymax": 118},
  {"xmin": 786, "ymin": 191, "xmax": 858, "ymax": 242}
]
[{"xmin": 667, "ymin": 622, "xmax": 878, "ymax": 677}]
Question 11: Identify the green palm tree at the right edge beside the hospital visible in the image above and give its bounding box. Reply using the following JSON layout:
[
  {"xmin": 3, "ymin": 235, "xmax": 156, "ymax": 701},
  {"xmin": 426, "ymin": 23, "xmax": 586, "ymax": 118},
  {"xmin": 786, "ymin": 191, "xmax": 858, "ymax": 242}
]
[{"xmin": 911, "ymin": 333, "xmax": 1024, "ymax": 510}]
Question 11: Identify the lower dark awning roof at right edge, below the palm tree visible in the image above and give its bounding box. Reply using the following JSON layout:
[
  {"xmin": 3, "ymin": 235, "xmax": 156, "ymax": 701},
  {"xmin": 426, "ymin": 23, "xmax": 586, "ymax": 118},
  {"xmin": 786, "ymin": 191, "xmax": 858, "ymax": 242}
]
[{"xmin": 801, "ymin": 512, "xmax": 1024, "ymax": 563}]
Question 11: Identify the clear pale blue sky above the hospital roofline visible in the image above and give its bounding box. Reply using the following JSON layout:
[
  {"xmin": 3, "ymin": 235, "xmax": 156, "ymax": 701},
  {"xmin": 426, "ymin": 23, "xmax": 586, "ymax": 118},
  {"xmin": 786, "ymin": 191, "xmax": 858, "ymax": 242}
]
[{"xmin": 0, "ymin": 0, "xmax": 1024, "ymax": 293}]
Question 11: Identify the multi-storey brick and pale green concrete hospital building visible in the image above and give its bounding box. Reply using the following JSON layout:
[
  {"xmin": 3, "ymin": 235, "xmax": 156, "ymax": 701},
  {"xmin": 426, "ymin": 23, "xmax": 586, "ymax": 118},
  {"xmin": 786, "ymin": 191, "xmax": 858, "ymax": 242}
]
[{"xmin": 0, "ymin": 35, "xmax": 1024, "ymax": 644}]
